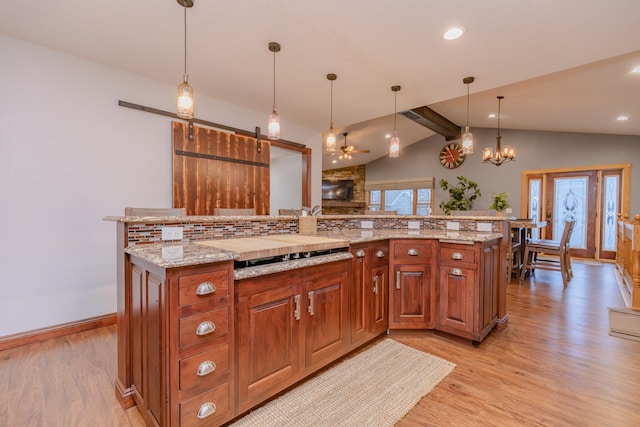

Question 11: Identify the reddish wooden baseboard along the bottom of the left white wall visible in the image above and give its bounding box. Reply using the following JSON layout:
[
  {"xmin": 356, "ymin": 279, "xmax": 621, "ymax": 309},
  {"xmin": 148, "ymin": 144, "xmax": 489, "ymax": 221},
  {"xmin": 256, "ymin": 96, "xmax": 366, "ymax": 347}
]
[{"xmin": 0, "ymin": 313, "xmax": 117, "ymax": 351}]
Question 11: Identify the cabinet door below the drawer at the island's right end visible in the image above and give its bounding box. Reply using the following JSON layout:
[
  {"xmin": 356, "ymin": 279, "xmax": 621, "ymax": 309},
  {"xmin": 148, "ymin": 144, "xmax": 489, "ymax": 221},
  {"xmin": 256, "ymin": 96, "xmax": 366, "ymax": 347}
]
[{"xmin": 438, "ymin": 266, "xmax": 475, "ymax": 338}]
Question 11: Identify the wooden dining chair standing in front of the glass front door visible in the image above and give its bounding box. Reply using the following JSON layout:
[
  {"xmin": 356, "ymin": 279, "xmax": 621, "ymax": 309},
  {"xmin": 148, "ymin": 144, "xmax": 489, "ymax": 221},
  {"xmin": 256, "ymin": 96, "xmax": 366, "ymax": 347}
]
[{"xmin": 520, "ymin": 221, "xmax": 575, "ymax": 287}]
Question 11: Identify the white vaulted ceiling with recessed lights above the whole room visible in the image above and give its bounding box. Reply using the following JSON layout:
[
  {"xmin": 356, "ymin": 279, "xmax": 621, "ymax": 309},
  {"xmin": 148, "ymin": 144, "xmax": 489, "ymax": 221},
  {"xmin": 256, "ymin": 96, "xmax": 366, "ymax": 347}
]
[{"xmin": 0, "ymin": 0, "xmax": 640, "ymax": 169}]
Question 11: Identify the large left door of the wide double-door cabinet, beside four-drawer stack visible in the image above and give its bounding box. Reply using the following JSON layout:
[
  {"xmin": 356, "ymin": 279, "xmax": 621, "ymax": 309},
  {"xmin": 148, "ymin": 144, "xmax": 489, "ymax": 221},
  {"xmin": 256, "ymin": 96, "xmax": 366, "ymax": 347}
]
[{"xmin": 236, "ymin": 285, "xmax": 306, "ymax": 412}]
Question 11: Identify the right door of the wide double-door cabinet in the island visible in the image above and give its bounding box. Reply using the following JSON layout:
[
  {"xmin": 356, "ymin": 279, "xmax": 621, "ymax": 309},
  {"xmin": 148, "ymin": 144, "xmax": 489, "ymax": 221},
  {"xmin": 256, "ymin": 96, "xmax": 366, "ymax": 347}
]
[{"xmin": 303, "ymin": 271, "xmax": 349, "ymax": 368}]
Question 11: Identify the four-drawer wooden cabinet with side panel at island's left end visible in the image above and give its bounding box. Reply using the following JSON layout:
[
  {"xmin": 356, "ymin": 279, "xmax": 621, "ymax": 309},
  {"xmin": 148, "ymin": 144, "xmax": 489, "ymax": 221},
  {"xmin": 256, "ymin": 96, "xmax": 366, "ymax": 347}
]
[{"xmin": 128, "ymin": 257, "xmax": 234, "ymax": 426}]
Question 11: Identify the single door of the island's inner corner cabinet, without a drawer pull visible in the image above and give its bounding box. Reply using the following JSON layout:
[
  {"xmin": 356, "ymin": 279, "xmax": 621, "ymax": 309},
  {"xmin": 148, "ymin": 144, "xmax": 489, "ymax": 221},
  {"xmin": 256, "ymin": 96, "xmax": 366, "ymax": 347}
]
[{"xmin": 389, "ymin": 264, "xmax": 435, "ymax": 329}]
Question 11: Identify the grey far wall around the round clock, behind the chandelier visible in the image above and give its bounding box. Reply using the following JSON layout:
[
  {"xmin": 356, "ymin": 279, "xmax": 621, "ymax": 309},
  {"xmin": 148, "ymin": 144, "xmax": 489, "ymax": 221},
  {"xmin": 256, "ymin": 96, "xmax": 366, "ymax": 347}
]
[{"xmin": 366, "ymin": 128, "xmax": 640, "ymax": 216}]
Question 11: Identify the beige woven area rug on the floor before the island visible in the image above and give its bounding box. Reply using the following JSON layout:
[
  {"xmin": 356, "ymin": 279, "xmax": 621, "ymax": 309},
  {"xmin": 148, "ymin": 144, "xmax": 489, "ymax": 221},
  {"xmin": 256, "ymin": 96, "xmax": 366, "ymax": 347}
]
[{"xmin": 231, "ymin": 338, "xmax": 455, "ymax": 427}]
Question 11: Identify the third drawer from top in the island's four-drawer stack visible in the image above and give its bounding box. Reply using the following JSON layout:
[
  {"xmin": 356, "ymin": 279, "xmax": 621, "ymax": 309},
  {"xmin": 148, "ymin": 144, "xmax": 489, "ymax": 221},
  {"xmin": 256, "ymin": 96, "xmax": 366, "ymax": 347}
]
[{"xmin": 180, "ymin": 344, "xmax": 229, "ymax": 391}]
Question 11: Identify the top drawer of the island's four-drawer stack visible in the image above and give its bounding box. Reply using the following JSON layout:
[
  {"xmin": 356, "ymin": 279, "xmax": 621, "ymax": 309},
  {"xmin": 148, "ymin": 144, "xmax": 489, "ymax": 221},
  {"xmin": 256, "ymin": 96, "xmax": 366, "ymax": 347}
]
[{"xmin": 178, "ymin": 269, "xmax": 229, "ymax": 306}]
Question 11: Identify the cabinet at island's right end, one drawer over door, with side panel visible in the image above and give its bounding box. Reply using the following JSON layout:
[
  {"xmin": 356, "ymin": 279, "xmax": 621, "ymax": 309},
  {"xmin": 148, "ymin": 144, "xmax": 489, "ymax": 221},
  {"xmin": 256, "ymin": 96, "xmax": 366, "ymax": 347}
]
[{"xmin": 437, "ymin": 240, "xmax": 500, "ymax": 341}]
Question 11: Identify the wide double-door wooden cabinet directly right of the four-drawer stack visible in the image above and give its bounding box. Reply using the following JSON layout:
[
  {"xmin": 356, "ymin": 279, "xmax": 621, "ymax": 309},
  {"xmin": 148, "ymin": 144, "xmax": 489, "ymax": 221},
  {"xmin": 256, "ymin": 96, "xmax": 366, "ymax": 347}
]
[{"xmin": 235, "ymin": 260, "xmax": 350, "ymax": 413}]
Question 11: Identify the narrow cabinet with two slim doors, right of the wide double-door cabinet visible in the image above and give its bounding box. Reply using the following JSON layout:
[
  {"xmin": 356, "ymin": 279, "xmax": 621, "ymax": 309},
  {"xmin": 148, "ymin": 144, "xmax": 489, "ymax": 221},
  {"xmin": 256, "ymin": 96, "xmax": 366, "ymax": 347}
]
[{"xmin": 350, "ymin": 241, "xmax": 389, "ymax": 346}]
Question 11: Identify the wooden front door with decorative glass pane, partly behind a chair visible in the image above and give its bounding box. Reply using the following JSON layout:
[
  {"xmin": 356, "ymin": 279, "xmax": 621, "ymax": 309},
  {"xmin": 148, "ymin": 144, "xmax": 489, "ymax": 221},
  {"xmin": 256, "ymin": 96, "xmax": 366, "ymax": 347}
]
[{"xmin": 545, "ymin": 171, "xmax": 598, "ymax": 258}]
